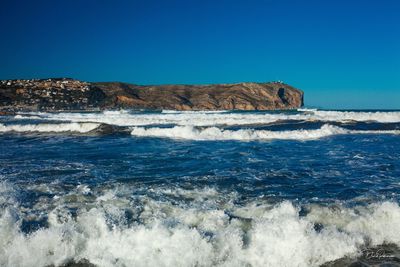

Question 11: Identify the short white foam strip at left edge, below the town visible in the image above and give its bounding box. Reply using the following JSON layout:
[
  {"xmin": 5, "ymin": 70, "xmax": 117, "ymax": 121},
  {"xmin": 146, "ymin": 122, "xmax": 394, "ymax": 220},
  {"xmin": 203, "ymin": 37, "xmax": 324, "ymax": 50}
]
[{"xmin": 0, "ymin": 122, "xmax": 100, "ymax": 133}]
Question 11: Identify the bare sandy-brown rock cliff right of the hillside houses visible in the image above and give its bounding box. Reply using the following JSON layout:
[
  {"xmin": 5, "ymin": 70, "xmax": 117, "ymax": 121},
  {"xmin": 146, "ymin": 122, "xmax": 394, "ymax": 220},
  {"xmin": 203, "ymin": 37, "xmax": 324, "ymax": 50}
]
[{"xmin": 92, "ymin": 82, "xmax": 303, "ymax": 110}]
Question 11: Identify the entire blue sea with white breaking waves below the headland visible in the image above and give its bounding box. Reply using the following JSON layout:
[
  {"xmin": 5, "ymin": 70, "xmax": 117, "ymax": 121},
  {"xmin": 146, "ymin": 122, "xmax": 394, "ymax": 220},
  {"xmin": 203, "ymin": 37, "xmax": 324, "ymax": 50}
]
[{"xmin": 0, "ymin": 109, "xmax": 400, "ymax": 267}]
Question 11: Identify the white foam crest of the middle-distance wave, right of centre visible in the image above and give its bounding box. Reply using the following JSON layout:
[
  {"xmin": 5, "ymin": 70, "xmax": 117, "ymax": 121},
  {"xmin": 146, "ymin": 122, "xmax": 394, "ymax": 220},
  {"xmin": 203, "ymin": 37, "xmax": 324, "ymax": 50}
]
[{"xmin": 131, "ymin": 124, "xmax": 400, "ymax": 141}]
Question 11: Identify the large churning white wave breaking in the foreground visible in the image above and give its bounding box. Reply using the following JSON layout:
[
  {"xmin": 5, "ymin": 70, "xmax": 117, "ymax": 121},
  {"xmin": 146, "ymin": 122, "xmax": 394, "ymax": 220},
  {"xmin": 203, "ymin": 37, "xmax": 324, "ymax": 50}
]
[{"xmin": 0, "ymin": 184, "xmax": 400, "ymax": 267}]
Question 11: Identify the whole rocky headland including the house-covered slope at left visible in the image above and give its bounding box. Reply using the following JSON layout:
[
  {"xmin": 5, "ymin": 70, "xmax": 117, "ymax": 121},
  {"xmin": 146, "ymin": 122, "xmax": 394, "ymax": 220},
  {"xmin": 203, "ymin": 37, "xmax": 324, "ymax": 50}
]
[{"xmin": 0, "ymin": 78, "xmax": 303, "ymax": 110}]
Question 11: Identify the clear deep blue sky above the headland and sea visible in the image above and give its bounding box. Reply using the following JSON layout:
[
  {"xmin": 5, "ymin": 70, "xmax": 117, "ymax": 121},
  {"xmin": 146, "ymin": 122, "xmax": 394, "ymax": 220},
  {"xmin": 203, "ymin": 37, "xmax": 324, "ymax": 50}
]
[{"xmin": 0, "ymin": 0, "xmax": 400, "ymax": 109}]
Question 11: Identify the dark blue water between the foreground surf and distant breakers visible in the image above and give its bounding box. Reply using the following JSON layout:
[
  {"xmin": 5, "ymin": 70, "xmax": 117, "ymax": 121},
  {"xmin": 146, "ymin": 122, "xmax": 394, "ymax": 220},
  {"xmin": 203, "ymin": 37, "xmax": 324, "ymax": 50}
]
[{"xmin": 0, "ymin": 134, "xmax": 400, "ymax": 203}]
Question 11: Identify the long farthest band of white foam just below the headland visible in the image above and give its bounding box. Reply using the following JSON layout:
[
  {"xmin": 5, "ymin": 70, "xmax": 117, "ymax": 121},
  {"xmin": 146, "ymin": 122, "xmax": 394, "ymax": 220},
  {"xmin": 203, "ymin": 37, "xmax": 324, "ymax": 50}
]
[{"xmin": 17, "ymin": 110, "xmax": 400, "ymax": 126}]
